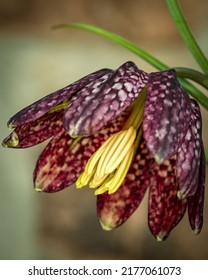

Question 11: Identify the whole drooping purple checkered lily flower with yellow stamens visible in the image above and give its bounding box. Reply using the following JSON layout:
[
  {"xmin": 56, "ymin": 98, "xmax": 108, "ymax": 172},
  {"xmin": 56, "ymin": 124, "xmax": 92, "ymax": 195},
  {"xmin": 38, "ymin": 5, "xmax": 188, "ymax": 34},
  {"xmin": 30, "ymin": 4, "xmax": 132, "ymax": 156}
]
[{"xmin": 3, "ymin": 62, "xmax": 205, "ymax": 240}]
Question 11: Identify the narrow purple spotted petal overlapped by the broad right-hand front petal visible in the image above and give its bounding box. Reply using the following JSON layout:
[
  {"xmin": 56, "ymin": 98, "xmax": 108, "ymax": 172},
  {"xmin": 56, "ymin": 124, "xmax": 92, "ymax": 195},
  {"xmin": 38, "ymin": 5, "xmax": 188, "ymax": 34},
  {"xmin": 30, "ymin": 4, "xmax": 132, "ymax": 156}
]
[{"xmin": 176, "ymin": 99, "xmax": 202, "ymax": 197}]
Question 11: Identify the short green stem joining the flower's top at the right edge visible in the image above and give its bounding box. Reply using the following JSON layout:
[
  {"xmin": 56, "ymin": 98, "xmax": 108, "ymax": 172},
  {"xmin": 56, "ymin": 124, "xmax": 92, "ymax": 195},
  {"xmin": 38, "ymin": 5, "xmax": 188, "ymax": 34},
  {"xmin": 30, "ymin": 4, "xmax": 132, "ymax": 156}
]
[{"xmin": 174, "ymin": 67, "xmax": 208, "ymax": 89}]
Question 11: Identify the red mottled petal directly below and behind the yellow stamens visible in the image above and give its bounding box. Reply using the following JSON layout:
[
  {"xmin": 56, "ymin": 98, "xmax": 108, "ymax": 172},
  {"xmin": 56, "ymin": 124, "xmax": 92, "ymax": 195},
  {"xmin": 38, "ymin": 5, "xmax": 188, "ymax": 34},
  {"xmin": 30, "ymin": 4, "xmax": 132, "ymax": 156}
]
[{"xmin": 97, "ymin": 141, "xmax": 151, "ymax": 230}]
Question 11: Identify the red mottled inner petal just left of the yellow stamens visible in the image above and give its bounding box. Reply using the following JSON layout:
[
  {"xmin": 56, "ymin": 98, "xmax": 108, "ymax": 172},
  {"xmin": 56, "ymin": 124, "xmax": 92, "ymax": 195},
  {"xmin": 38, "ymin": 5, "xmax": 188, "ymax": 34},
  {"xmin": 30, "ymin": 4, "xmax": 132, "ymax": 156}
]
[{"xmin": 34, "ymin": 130, "xmax": 91, "ymax": 192}]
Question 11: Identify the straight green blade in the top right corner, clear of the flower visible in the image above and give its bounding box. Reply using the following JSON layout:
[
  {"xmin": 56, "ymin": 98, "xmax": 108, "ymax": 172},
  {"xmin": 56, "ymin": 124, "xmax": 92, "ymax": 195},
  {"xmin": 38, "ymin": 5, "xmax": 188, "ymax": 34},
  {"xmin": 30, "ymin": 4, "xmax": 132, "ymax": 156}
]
[{"xmin": 166, "ymin": 0, "xmax": 208, "ymax": 75}]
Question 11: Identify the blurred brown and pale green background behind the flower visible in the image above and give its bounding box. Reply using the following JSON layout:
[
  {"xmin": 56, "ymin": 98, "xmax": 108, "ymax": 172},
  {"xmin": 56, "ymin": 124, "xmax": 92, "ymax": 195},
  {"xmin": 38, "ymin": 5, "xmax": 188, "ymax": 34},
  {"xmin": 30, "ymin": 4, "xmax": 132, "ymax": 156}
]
[{"xmin": 0, "ymin": 0, "xmax": 208, "ymax": 259}]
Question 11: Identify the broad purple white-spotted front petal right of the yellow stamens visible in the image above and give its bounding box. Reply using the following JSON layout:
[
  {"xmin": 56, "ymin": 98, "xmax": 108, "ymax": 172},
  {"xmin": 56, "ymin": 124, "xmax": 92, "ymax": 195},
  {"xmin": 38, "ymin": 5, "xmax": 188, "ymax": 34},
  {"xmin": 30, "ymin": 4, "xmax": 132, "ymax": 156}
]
[{"xmin": 143, "ymin": 70, "xmax": 191, "ymax": 162}]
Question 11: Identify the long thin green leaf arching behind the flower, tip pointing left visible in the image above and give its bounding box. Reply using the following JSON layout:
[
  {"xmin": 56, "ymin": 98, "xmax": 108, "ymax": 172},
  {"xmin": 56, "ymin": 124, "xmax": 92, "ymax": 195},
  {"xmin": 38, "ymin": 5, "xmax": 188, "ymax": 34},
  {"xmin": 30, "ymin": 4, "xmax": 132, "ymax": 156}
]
[{"xmin": 53, "ymin": 23, "xmax": 208, "ymax": 110}]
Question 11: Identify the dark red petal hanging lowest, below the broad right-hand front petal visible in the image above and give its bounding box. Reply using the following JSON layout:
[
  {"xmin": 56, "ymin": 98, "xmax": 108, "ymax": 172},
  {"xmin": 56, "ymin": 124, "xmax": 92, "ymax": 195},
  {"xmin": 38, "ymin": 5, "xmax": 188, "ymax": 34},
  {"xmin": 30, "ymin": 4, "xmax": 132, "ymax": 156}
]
[{"xmin": 148, "ymin": 158, "xmax": 186, "ymax": 241}]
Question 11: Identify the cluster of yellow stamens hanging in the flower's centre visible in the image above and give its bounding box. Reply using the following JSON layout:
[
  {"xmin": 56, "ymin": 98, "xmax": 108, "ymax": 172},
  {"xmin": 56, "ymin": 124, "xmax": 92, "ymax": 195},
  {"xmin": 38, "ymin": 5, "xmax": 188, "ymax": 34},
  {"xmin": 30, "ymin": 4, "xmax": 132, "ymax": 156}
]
[{"xmin": 76, "ymin": 89, "xmax": 146, "ymax": 195}]
